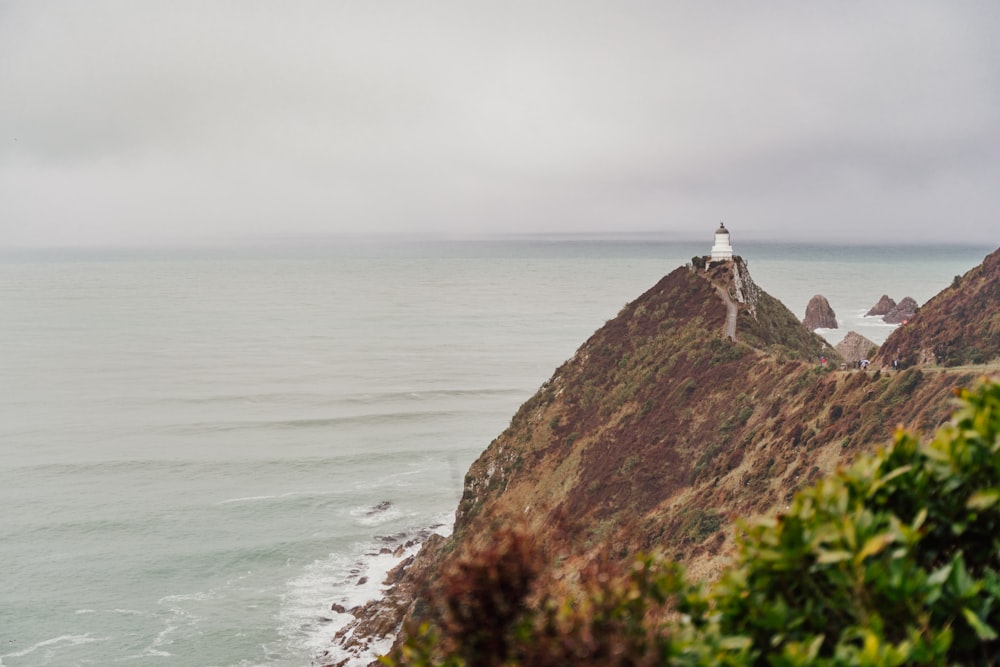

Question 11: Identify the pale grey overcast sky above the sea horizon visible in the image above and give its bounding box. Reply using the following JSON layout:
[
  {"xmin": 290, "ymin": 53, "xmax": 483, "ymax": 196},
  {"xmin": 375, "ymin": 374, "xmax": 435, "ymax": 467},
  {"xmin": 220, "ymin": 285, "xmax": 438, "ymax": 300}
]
[{"xmin": 0, "ymin": 0, "xmax": 1000, "ymax": 247}]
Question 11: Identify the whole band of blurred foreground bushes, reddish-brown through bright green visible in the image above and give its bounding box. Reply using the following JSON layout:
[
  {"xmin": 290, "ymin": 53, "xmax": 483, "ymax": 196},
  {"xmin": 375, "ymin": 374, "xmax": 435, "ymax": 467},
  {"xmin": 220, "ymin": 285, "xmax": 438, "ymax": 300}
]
[{"xmin": 383, "ymin": 382, "xmax": 1000, "ymax": 667}]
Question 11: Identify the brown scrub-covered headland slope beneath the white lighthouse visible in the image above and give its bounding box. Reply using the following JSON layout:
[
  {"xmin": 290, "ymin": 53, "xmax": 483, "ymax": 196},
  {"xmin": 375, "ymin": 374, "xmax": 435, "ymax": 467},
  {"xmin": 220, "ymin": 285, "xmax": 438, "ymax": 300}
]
[{"xmin": 338, "ymin": 252, "xmax": 995, "ymax": 664}]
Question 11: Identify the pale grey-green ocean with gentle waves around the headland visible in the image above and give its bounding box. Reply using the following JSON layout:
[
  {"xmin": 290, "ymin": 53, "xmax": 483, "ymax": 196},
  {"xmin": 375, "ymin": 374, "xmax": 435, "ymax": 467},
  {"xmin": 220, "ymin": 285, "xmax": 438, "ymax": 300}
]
[{"xmin": 0, "ymin": 237, "xmax": 993, "ymax": 667}]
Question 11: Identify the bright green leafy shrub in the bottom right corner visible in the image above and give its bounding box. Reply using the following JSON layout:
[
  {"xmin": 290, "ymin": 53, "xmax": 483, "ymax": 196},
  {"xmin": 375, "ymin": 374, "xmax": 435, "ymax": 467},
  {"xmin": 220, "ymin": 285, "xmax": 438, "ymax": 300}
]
[{"xmin": 712, "ymin": 384, "xmax": 1000, "ymax": 665}]
